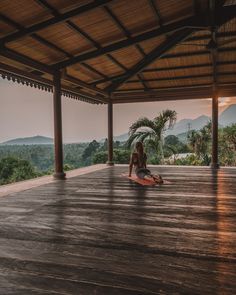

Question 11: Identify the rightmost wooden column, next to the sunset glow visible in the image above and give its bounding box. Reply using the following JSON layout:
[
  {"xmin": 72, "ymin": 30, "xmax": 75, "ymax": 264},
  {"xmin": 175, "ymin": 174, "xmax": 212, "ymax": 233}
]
[{"xmin": 211, "ymin": 88, "xmax": 219, "ymax": 168}]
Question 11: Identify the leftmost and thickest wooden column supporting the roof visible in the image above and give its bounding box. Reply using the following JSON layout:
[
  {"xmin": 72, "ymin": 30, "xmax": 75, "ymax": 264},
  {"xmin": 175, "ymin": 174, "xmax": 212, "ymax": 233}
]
[{"xmin": 53, "ymin": 71, "xmax": 65, "ymax": 179}]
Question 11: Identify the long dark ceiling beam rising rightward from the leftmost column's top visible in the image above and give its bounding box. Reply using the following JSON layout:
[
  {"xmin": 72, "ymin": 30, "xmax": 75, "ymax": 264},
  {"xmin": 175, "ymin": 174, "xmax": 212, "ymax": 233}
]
[{"xmin": 54, "ymin": 17, "xmax": 203, "ymax": 69}]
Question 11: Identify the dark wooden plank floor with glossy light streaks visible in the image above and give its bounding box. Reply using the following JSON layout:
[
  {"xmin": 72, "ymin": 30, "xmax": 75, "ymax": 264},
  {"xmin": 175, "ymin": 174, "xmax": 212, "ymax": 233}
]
[{"xmin": 0, "ymin": 167, "xmax": 236, "ymax": 295}]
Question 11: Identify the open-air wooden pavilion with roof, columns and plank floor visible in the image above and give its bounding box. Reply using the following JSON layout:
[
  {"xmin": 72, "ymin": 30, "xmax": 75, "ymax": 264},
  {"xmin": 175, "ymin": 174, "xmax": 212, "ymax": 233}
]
[{"xmin": 0, "ymin": 0, "xmax": 236, "ymax": 295}]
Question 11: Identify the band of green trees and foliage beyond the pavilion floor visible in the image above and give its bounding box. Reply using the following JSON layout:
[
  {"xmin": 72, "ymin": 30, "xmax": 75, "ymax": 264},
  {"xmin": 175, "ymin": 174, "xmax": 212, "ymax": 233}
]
[{"xmin": 0, "ymin": 121, "xmax": 236, "ymax": 185}]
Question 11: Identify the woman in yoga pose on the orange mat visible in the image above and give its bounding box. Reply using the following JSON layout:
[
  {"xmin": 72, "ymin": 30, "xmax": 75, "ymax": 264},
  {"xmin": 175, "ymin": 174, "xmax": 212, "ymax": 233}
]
[{"xmin": 129, "ymin": 141, "xmax": 163, "ymax": 183}]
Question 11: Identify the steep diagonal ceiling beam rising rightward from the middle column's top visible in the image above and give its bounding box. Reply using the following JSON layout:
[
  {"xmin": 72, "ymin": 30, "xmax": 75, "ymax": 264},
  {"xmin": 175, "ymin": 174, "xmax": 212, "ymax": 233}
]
[{"xmin": 105, "ymin": 29, "xmax": 194, "ymax": 92}]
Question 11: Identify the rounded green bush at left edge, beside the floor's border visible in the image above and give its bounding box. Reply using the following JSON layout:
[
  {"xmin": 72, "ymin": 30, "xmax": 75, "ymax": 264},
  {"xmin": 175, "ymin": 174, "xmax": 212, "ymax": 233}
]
[{"xmin": 0, "ymin": 157, "xmax": 38, "ymax": 185}]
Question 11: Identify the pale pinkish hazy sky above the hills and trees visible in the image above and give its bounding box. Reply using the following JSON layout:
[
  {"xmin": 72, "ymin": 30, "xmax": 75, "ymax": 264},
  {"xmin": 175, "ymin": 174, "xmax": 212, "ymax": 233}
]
[{"xmin": 0, "ymin": 78, "xmax": 236, "ymax": 143}]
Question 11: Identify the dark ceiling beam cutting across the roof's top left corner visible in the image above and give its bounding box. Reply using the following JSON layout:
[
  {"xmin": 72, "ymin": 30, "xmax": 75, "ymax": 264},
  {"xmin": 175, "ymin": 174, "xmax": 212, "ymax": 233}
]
[{"xmin": 0, "ymin": 0, "xmax": 112, "ymax": 44}]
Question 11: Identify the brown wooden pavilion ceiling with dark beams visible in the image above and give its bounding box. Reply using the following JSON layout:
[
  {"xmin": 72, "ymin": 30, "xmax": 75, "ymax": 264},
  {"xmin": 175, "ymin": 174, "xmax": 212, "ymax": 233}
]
[{"xmin": 0, "ymin": 0, "xmax": 236, "ymax": 103}]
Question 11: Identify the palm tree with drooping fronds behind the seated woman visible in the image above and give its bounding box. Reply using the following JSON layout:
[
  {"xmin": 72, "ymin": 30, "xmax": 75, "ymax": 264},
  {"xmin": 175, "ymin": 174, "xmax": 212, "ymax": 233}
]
[{"xmin": 127, "ymin": 110, "xmax": 177, "ymax": 163}]
